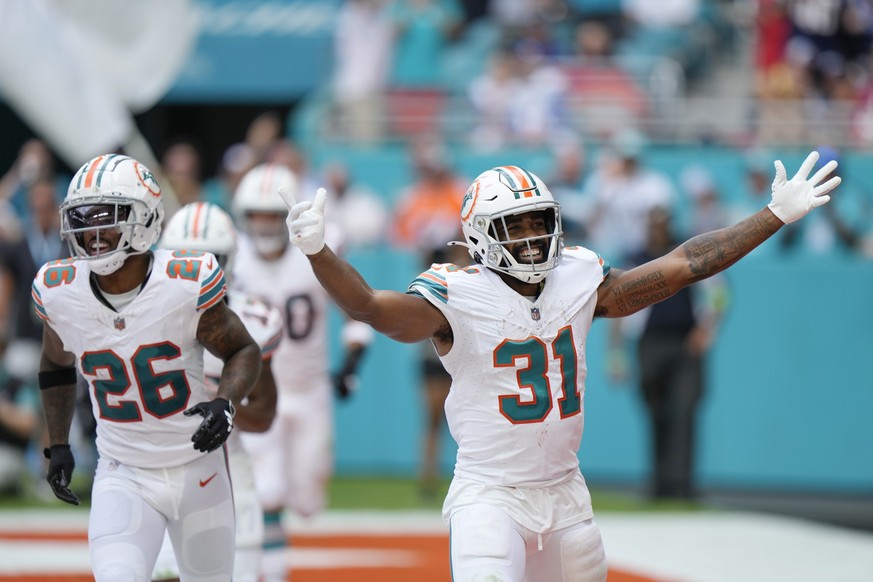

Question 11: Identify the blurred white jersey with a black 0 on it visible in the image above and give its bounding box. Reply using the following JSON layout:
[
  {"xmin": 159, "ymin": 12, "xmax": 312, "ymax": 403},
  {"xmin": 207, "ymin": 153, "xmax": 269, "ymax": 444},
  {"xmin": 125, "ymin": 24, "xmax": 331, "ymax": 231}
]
[{"xmin": 231, "ymin": 236, "xmax": 330, "ymax": 392}]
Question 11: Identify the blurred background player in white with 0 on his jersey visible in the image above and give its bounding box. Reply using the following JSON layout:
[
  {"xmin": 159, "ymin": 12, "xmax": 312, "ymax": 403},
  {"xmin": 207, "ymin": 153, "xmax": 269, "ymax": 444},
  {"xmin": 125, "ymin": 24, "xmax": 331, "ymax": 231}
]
[{"xmin": 233, "ymin": 164, "xmax": 372, "ymax": 582}]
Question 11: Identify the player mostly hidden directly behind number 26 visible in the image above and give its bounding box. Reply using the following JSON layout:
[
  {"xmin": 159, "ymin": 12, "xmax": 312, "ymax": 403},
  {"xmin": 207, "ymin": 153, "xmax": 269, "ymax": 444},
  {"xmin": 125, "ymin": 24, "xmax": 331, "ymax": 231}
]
[{"xmin": 152, "ymin": 202, "xmax": 282, "ymax": 582}]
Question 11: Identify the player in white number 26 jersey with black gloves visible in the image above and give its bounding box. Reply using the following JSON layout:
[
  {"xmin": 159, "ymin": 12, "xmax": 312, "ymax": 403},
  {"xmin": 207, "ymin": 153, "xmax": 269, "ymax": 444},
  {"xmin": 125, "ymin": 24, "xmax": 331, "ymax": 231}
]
[{"xmin": 33, "ymin": 154, "xmax": 261, "ymax": 582}]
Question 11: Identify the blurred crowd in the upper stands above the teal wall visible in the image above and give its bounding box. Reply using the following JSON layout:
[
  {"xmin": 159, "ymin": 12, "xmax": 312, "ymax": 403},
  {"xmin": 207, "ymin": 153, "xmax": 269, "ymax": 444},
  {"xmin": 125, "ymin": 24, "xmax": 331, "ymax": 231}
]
[{"xmin": 330, "ymin": 0, "xmax": 873, "ymax": 151}]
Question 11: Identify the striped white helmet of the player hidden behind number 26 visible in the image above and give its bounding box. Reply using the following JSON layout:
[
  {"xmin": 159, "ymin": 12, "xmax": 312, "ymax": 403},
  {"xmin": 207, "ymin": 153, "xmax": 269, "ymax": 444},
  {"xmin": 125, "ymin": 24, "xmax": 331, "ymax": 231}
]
[{"xmin": 159, "ymin": 202, "xmax": 236, "ymax": 279}]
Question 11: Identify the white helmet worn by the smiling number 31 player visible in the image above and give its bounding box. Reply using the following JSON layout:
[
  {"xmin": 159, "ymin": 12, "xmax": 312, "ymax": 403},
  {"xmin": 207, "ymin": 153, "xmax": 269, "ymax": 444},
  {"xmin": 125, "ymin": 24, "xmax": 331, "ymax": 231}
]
[{"xmin": 461, "ymin": 166, "xmax": 562, "ymax": 283}]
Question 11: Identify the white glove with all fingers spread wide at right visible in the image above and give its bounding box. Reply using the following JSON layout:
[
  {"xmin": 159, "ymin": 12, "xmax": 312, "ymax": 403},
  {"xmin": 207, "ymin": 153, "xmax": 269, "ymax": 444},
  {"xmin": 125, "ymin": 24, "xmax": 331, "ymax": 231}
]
[{"xmin": 767, "ymin": 151, "xmax": 842, "ymax": 224}]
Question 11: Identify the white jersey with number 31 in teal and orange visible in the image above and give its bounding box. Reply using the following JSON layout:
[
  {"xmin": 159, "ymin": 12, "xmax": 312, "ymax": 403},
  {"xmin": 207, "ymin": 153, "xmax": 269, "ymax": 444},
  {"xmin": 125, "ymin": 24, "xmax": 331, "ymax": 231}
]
[{"xmin": 409, "ymin": 247, "xmax": 608, "ymax": 487}]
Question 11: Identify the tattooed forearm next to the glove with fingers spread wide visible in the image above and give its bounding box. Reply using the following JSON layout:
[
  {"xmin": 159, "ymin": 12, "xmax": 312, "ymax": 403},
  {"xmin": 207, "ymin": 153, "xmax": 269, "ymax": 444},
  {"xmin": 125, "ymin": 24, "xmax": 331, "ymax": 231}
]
[{"xmin": 674, "ymin": 208, "xmax": 784, "ymax": 282}]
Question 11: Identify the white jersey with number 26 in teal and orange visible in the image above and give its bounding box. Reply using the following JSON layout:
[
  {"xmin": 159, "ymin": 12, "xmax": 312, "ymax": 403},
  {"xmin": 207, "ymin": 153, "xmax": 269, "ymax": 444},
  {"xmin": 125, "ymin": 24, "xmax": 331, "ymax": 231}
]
[{"xmin": 32, "ymin": 249, "xmax": 227, "ymax": 469}]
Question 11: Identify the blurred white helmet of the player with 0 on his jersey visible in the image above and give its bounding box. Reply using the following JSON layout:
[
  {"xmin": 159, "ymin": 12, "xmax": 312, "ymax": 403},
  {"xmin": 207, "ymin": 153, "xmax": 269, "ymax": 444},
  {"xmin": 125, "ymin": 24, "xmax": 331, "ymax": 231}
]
[{"xmin": 232, "ymin": 164, "xmax": 300, "ymax": 254}]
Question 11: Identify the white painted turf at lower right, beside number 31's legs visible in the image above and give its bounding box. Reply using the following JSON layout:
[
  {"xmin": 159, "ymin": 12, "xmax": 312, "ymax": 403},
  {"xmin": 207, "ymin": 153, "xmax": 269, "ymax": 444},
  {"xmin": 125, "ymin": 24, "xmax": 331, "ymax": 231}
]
[{"xmin": 595, "ymin": 512, "xmax": 873, "ymax": 582}]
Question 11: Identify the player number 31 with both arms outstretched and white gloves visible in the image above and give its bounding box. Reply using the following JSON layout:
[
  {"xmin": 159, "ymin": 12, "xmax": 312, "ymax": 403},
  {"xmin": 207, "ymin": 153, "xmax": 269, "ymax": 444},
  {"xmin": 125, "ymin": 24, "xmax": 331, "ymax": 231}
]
[{"xmin": 287, "ymin": 152, "xmax": 840, "ymax": 582}]
